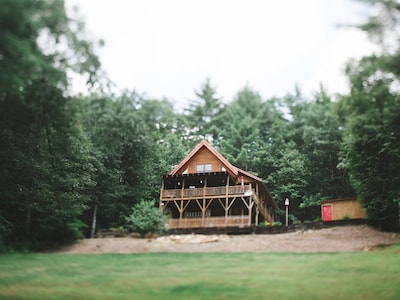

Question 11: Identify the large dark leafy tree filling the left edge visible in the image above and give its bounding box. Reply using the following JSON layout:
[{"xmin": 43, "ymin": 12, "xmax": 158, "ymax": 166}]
[{"xmin": 0, "ymin": 0, "xmax": 100, "ymax": 247}]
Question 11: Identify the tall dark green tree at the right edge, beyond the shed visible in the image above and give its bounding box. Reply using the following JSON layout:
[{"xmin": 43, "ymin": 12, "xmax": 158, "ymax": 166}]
[{"xmin": 340, "ymin": 0, "xmax": 400, "ymax": 230}]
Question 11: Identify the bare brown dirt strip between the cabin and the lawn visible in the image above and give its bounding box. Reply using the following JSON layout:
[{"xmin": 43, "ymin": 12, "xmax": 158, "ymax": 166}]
[{"xmin": 57, "ymin": 225, "xmax": 400, "ymax": 253}]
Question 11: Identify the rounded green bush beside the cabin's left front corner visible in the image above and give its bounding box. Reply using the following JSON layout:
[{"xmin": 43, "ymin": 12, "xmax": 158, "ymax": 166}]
[{"xmin": 125, "ymin": 201, "xmax": 168, "ymax": 237}]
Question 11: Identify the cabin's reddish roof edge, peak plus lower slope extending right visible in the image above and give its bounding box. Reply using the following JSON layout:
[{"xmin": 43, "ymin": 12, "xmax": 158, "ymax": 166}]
[{"xmin": 169, "ymin": 140, "xmax": 262, "ymax": 182}]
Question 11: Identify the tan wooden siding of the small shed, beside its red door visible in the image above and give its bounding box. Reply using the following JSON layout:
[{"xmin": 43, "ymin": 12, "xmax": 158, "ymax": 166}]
[{"xmin": 321, "ymin": 199, "xmax": 366, "ymax": 221}]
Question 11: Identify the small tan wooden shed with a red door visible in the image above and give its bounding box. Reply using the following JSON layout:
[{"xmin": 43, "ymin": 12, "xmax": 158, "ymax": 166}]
[{"xmin": 321, "ymin": 198, "xmax": 367, "ymax": 222}]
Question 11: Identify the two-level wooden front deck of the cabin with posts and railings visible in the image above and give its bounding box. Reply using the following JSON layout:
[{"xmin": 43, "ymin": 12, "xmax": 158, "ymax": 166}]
[{"xmin": 160, "ymin": 184, "xmax": 272, "ymax": 228}]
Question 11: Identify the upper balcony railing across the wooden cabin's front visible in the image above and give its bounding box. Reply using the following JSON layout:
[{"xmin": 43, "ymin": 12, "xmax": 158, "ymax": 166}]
[{"xmin": 161, "ymin": 185, "xmax": 251, "ymax": 200}]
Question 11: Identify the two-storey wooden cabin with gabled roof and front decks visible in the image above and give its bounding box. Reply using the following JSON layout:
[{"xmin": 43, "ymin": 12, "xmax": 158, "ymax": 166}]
[{"xmin": 160, "ymin": 140, "xmax": 277, "ymax": 228}]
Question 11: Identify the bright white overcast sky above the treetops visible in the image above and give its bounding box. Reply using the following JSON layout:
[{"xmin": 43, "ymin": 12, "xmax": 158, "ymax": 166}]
[{"xmin": 66, "ymin": 0, "xmax": 372, "ymax": 107}]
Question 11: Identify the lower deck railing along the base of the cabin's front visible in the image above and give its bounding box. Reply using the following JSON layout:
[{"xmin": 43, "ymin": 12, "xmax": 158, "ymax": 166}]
[{"xmin": 168, "ymin": 215, "xmax": 249, "ymax": 228}]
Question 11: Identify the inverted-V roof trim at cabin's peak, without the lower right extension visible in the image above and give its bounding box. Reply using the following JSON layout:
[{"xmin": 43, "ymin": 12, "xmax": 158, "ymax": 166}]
[{"xmin": 169, "ymin": 140, "xmax": 238, "ymax": 177}]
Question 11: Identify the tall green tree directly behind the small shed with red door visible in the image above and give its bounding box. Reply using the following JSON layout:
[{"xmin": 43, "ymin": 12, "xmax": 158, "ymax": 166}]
[{"xmin": 289, "ymin": 86, "xmax": 354, "ymax": 219}]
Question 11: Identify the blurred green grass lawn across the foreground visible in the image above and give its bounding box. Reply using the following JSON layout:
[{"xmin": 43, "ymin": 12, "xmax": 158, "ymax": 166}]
[{"xmin": 0, "ymin": 245, "xmax": 400, "ymax": 300}]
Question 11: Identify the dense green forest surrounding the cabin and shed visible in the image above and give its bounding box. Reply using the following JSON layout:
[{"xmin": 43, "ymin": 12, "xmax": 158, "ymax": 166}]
[{"xmin": 0, "ymin": 0, "xmax": 400, "ymax": 251}]
